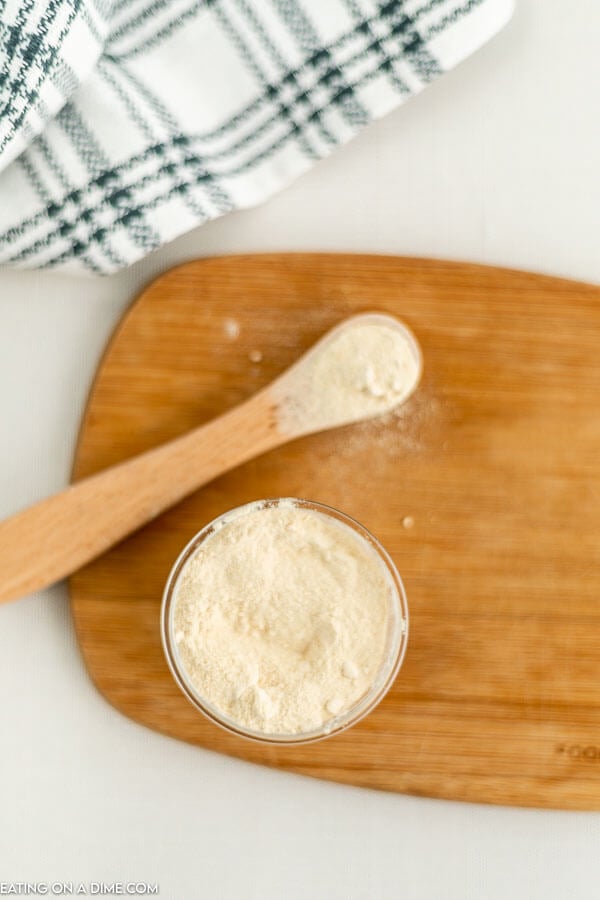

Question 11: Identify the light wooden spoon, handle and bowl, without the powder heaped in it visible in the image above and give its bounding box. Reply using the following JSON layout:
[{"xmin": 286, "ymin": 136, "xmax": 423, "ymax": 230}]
[{"xmin": 0, "ymin": 313, "xmax": 422, "ymax": 602}]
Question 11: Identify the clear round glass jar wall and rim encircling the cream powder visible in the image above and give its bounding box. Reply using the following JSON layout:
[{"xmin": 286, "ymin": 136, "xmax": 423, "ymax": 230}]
[{"xmin": 161, "ymin": 498, "xmax": 408, "ymax": 744}]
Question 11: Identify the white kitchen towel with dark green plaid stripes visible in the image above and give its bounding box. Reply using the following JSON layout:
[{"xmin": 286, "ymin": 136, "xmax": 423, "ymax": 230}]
[{"xmin": 0, "ymin": 0, "xmax": 513, "ymax": 273}]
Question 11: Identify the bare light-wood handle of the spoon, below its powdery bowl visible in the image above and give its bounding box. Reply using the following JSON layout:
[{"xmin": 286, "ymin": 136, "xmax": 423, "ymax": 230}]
[{"xmin": 0, "ymin": 391, "xmax": 278, "ymax": 602}]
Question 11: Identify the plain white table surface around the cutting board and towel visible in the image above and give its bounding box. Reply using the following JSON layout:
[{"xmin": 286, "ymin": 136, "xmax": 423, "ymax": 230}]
[{"xmin": 0, "ymin": 0, "xmax": 600, "ymax": 900}]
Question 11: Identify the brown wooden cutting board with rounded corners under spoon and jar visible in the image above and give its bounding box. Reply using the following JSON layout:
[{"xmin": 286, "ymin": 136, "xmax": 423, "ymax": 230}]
[{"xmin": 71, "ymin": 255, "xmax": 600, "ymax": 809}]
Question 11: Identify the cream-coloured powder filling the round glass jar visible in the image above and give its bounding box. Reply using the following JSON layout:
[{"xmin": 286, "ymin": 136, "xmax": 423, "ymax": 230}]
[{"xmin": 171, "ymin": 500, "xmax": 395, "ymax": 735}]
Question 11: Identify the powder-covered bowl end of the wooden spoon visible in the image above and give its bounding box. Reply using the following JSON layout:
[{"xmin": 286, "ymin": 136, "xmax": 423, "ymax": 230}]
[{"xmin": 276, "ymin": 314, "xmax": 421, "ymax": 433}]
